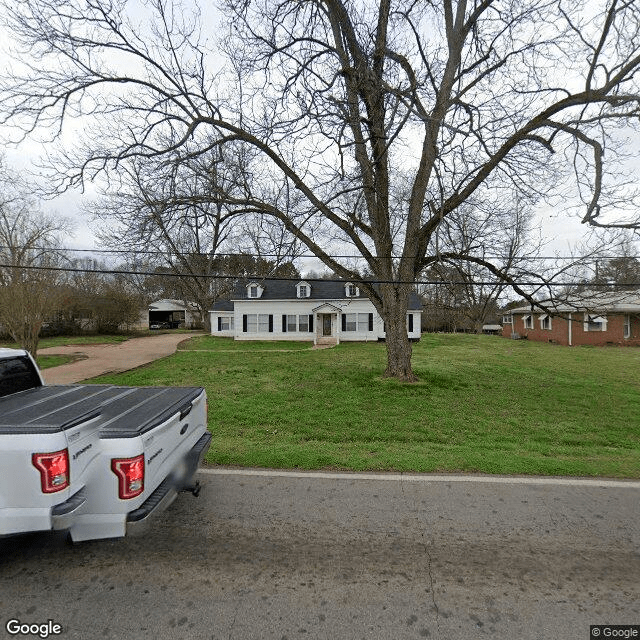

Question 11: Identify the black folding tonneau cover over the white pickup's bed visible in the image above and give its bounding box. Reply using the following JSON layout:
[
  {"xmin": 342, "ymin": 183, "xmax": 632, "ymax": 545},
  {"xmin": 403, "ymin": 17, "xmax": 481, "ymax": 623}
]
[{"xmin": 0, "ymin": 385, "xmax": 203, "ymax": 438}]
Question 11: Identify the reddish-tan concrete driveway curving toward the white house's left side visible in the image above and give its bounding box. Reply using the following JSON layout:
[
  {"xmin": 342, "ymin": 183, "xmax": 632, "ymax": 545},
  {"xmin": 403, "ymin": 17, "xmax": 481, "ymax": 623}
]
[{"xmin": 38, "ymin": 332, "xmax": 202, "ymax": 384}]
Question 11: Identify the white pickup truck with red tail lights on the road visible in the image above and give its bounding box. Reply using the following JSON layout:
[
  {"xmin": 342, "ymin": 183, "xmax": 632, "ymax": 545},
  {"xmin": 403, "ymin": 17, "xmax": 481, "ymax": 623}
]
[{"xmin": 0, "ymin": 349, "xmax": 211, "ymax": 541}]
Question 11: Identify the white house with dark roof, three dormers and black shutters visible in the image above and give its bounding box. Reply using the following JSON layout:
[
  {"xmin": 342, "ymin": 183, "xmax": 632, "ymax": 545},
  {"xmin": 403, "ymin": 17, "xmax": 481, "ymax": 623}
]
[{"xmin": 209, "ymin": 279, "xmax": 422, "ymax": 344}]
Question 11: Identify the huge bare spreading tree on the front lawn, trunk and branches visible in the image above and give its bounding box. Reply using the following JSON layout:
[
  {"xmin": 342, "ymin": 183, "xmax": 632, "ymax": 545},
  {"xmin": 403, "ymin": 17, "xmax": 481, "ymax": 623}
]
[{"xmin": 2, "ymin": 0, "xmax": 640, "ymax": 380}]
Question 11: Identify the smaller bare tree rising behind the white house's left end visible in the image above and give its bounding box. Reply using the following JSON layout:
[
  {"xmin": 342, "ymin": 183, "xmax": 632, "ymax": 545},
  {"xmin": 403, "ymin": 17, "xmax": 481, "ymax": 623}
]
[{"xmin": 91, "ymin": 154, "xmax": 238, "ymax": 326}]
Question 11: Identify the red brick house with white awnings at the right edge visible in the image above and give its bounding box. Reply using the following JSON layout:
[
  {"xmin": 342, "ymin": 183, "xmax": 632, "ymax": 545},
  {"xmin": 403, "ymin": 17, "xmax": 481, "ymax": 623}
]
[{"xmin": 502, "ymin": 291, "xmax": 640, "ymax": 346}]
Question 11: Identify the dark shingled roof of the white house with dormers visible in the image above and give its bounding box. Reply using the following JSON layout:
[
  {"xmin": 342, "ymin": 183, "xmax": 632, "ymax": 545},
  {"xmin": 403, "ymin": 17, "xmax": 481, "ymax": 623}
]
[{"xmin": 211, "ymin": 278, "xmax": 422, "ymax": 311}]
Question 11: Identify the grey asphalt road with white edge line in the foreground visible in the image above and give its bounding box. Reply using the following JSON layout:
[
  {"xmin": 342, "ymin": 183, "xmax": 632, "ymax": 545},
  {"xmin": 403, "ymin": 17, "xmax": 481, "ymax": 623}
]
[{"xmin": 0, "ymin": 469, "xmax": 640, "ymax": 640}]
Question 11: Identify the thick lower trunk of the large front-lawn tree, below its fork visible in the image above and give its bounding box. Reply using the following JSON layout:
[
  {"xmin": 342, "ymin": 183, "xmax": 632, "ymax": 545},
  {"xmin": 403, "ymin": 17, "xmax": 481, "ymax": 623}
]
[{"xmin": 381, "ymin": 285, "xmax": 418, "ymax": 382}]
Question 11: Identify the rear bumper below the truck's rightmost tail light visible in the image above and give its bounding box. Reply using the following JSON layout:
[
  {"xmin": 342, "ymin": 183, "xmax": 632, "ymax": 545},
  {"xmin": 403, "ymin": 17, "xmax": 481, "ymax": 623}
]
[{"xmin": 127, "ymin": 432, "xmax": 211, "ymax": 535}]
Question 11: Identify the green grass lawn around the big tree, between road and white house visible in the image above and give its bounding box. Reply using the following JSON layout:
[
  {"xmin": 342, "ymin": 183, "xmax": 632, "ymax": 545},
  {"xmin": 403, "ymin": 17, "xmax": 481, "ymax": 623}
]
[{"xmin": 86, "ymin": 334, "xmax": 640, "ymax": 478}]
